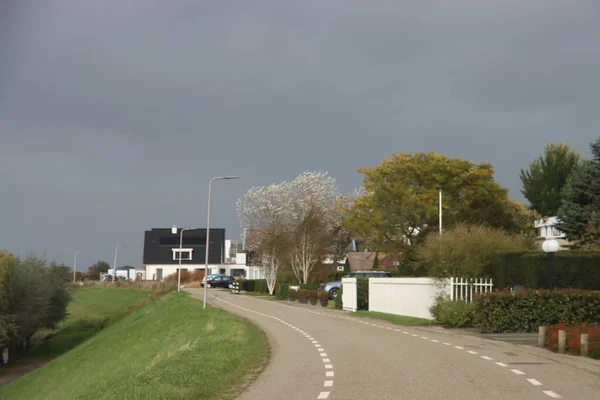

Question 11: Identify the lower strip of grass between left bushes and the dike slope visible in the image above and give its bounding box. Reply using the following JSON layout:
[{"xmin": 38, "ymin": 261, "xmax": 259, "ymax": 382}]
[{"xmin": 25, "ymin": 287, "xmax": 151, "ymax": 360}]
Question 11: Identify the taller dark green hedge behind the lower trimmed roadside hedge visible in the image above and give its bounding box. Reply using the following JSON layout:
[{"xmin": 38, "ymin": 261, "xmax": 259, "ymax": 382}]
[{"xmin": 484, "ymin": 250, "xmax": 600, "ymax": 290}]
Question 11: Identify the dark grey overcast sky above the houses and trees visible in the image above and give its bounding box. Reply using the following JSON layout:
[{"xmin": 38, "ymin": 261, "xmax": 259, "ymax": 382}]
[{"xmin": 0, "ymin": 0, "xmax": 600, "ymax": 268}]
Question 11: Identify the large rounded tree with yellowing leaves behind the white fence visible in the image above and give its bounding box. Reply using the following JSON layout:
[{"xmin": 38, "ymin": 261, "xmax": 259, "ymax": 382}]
[{"xmin": 341, "ymin": 153, "xmax": 533, "ymax": 251}]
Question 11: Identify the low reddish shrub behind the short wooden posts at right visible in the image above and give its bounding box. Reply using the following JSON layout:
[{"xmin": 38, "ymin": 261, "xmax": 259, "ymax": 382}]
[{"xmin": 546, "ymin": 322, "xmax": 600, "ymax": 359}]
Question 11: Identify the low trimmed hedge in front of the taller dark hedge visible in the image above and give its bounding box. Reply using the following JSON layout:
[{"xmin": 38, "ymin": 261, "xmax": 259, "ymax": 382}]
[{"xmin": 475, "ymin": 289, "xmax": 600, "ymax": 332}]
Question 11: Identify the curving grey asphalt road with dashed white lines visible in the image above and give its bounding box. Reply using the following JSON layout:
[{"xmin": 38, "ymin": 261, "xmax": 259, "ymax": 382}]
[{"xmin": 187, "ymin": 289, "xmax": 600, "ymax": 400}]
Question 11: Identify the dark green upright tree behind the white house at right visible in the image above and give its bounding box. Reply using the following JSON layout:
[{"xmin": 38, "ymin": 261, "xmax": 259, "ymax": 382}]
[{"xmin": 521, "ymin": 143, "xmax": 581, "ymax": 217}]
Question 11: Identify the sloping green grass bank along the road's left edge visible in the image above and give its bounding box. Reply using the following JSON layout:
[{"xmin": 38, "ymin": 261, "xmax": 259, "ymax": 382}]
[{"xmin": 0, "ymin": 293, "xmax": 269, "ymax": 400}]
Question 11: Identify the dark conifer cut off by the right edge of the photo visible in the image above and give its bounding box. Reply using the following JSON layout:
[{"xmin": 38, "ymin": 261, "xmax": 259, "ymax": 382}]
[{"xmin": 557, "ymin": 137, "xmax": 600, "ymax": 246}]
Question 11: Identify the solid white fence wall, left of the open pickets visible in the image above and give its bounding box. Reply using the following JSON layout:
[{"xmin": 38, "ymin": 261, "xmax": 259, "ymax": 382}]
[{"xmin": 366, "ymin": 278, "xmax": 450, "ymax": 319}]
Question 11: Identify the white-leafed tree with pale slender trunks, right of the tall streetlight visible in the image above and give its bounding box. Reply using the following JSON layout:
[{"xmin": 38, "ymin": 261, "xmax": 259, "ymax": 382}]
[{"xmin": 237, "ymin": 172, "xmax": 340, "ymax": 294}]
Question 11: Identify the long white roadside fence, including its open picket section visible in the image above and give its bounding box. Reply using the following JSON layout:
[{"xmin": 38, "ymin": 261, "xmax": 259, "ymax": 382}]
[{"xmin": 342, "ymin": 278, "xmax": 493, "ymax": 319}]
